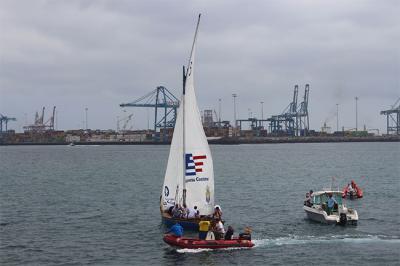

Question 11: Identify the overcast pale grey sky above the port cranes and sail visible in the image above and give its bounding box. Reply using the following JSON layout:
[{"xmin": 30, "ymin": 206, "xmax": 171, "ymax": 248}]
[{"xmin": 0, "ymin": 0, "xmax": 400, "ymax": 131}]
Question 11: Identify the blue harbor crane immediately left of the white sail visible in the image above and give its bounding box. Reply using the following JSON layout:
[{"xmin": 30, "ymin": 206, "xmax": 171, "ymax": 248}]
[{"xmin": 119, "ymin": 86, "xmax": 179, "ymax": 142}]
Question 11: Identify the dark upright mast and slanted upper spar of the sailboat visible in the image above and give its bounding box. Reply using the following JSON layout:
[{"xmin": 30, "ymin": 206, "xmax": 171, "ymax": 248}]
[{"xmin": 181, "ymin": 14, "xmax": 201, "ymax": 205}]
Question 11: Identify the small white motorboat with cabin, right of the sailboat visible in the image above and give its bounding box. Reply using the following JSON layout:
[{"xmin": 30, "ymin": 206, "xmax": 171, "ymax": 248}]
[{"xmin": 303, "ymin": 190, "xmax": 358, "ymax": 225}]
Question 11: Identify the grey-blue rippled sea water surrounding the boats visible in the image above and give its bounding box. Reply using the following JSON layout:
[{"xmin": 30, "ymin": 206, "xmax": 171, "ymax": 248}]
[{"xmin": 0, "ymin": 143, "xmax": 400, "ymax": 265}]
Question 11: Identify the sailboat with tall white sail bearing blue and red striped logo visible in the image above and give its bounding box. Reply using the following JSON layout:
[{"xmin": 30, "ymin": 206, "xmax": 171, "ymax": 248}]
[{"xmin": 160, "ymin": 15, "xmax": 214, "ymax": 230}]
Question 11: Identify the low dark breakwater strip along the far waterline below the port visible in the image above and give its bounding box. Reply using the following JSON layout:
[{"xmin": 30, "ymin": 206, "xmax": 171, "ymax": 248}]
[{"xmin": 0, "ymin": 135, "xmax": 400, "ymax": 146}]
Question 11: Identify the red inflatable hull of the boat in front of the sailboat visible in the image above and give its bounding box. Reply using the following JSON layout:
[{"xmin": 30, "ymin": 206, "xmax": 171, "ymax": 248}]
[{"xmin": 163, "ymin": 234, "xmax": 254, "ymax": 249}]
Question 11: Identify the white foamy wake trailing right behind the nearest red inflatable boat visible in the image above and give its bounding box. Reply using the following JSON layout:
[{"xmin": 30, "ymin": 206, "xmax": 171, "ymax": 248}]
[{"xmin": 253, "ymin": 235, "xmax": 400, "ymax": 248}]
